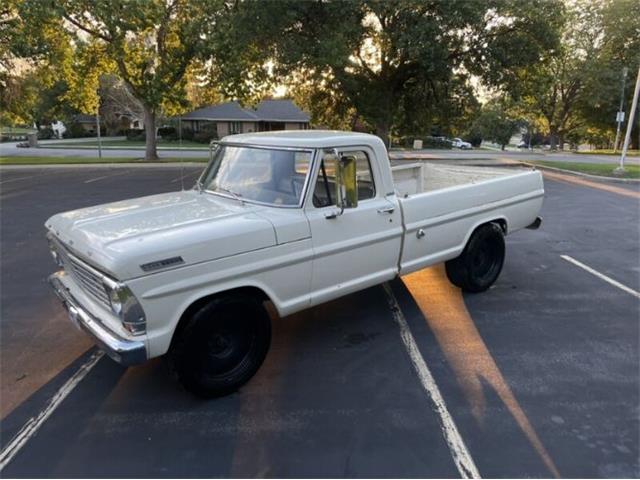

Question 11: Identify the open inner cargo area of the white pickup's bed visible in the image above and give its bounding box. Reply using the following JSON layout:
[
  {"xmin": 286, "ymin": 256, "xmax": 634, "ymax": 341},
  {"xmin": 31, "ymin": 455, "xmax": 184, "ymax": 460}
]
[{"xmin": 391, "ymin": 162, "xmax": 528, "ymax": 198}]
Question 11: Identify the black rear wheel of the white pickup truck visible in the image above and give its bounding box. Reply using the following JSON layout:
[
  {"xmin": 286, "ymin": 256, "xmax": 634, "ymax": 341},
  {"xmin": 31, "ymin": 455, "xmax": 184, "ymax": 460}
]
[{"xmin": 445, "ymin": 223, "xmax": 505, "ymax": 293}]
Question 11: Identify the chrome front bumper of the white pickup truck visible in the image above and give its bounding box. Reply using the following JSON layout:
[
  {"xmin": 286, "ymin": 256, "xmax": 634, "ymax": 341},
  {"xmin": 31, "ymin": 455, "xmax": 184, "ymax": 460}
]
[{"xmin": 49, "ymin": 270, "xmax": 147, "ymax": 366}]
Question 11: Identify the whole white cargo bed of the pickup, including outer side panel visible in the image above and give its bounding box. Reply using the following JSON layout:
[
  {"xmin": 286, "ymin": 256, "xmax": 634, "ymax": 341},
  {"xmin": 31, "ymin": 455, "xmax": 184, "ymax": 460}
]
[{"xmin": 392, "ymin": 163, "xmax": 544, "ymax": 274}]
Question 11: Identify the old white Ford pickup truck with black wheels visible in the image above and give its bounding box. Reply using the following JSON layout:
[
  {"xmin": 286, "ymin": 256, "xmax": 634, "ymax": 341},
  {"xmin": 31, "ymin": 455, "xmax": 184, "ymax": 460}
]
[{"xmin": 46, "ymin": 131, "xmax": 544, "ymax": 397}]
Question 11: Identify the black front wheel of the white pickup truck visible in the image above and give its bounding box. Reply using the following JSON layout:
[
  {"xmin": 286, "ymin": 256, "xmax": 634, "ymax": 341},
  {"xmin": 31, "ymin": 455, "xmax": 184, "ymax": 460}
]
[{"xmin": 168, "ymin": 296, "xmax": 271, "ymax": 398}]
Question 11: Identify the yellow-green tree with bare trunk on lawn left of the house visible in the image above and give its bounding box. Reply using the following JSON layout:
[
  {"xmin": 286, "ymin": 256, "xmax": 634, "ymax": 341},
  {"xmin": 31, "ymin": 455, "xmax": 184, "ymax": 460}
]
[{"xmin": 20, "ymin": 0, "xmax": 231, "ymax": 160}]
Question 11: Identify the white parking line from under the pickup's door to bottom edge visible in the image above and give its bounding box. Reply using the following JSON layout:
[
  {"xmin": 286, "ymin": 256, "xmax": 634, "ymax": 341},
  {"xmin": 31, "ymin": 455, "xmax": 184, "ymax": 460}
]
[{"xmin": 384, "ymin": 283, "xmax": 481, "ymax": 478}]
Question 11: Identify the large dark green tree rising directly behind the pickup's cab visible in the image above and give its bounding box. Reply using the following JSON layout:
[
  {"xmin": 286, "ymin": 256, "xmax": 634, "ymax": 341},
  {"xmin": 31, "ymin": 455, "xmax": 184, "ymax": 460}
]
[{"xmin": 224, "ymin": 0, "xmax": 559, "ymax": 144}]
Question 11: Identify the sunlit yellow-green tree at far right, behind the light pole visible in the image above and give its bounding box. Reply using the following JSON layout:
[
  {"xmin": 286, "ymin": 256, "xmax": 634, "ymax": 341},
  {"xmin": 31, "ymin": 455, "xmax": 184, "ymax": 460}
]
[{"xmin": 509, "ymin": 0, "xmax": 640, "ymax": 149}]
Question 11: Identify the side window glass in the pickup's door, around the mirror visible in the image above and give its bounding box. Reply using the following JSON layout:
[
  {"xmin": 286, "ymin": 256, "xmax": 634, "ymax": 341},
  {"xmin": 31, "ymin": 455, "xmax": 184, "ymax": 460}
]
[{"xmin": 313, "ymin": 150, "xmax": 376, "ymax": 208}]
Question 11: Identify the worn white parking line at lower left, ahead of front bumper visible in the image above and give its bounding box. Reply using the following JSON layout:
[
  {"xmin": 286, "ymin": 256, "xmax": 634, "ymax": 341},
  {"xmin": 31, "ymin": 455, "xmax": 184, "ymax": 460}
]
[{"xmin": 0, "ymin": 351, "xmax": 104, "ymax": 472}]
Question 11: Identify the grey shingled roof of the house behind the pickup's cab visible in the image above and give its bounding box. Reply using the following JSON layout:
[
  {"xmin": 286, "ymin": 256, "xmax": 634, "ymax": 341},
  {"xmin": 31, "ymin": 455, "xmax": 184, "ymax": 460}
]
[{"xmin": 182, "ymin": 99, "xmax": 309, "ymax": 122}]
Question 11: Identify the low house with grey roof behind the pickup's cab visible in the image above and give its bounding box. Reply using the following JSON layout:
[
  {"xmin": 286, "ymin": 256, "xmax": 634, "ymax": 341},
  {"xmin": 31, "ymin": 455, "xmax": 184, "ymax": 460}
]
[{"xmin": 180, "ymin": 99, "xmax": 309, "ymax": 138}]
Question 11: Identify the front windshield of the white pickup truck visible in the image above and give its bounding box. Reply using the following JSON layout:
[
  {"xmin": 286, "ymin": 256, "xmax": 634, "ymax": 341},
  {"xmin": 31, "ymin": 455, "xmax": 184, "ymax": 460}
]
[{"xmin": 200, "ymin": 144, "xmax": 311, "ymax": 206}]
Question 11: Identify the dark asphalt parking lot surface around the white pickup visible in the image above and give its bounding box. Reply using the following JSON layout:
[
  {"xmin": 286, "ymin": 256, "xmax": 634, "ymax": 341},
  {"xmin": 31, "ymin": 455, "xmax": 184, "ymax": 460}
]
[{"xmin": 0, "ymin": 167, "xmax": 640, "ymax": 477}]
